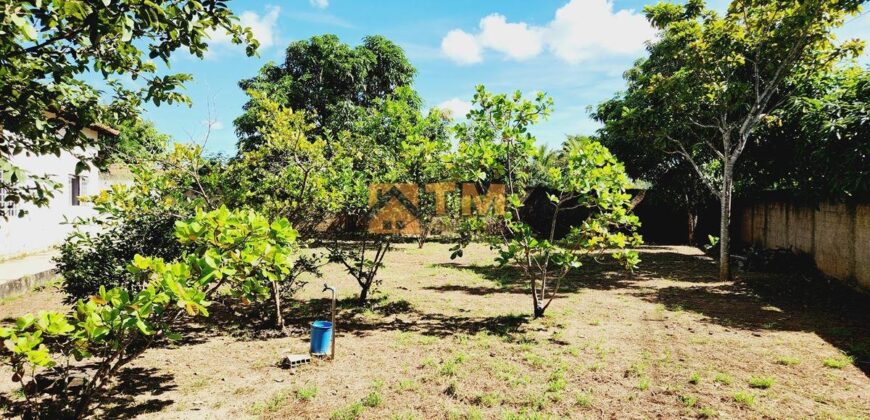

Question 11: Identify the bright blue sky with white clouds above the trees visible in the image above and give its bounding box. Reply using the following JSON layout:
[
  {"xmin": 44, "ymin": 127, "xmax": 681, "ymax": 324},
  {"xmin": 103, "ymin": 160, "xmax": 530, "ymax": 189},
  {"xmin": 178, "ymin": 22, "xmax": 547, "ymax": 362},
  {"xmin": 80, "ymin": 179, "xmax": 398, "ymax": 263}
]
[{"xmin": 146, "ymin": 0, "xmax": 870, "ymax": 153}]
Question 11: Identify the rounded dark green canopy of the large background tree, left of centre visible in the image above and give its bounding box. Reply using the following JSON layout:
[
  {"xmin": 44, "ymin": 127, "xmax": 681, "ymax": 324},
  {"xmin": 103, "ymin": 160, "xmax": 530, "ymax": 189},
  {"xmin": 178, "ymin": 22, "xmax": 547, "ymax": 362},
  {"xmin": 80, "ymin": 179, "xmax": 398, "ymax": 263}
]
[{"xmin": 235, "ymin": 35, "xmax": 415, "ymax": 150}]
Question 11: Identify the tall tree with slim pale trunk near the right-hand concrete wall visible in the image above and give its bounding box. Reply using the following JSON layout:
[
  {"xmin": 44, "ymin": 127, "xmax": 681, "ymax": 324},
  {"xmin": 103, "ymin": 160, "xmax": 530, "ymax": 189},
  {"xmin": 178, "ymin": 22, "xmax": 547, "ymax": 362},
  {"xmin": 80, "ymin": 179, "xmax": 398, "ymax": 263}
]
[{"xmin": 608, "ymin": 0, "xmax": 863, "ymax": 279}]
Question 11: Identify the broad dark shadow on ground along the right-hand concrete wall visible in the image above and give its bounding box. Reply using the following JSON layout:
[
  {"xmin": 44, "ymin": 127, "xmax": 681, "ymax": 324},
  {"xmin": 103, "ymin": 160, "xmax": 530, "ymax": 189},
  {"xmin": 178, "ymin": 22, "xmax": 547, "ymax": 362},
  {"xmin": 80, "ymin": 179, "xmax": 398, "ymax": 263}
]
[{"xmin": 631, "ymin": 252, "xmax": 870, "ymax": 376}]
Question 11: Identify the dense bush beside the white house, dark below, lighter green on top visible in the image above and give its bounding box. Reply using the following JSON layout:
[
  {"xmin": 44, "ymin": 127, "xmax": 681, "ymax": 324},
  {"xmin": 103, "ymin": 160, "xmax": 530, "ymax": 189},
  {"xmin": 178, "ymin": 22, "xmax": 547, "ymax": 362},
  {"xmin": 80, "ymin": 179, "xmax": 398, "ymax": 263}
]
[{"xmin": 56, "ymin": 145, "xmax": 223, "ymax": 299}]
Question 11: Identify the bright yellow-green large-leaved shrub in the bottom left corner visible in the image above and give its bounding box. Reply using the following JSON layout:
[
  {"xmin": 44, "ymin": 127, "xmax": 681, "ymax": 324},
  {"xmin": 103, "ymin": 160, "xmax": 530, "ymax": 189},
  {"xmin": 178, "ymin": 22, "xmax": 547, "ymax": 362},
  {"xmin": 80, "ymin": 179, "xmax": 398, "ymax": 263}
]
[{"xmin": 0, "ymin": 257, "xmax": 208, "ymax": 416}]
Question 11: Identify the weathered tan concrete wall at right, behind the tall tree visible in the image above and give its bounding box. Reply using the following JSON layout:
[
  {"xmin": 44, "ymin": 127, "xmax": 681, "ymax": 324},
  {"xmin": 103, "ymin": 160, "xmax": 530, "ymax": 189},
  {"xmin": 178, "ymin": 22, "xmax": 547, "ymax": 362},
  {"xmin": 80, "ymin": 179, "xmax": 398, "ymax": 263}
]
[{"xmin": 737, "ymin": 200, "xmax": 870, "ymax": 290}]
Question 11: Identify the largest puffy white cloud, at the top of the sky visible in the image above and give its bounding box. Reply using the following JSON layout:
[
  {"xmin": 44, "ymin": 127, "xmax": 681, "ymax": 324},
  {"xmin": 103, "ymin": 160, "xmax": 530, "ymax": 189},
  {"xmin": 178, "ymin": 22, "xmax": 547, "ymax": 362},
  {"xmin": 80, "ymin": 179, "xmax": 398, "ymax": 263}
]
[{"xmin": 441, "ymin": 0, "xmax": 655, "ymax": 64}]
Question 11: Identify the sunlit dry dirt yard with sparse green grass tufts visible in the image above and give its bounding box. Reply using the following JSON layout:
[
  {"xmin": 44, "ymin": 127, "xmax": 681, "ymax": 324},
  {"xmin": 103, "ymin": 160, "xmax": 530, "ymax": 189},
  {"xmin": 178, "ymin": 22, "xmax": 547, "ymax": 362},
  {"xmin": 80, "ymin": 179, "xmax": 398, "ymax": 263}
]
[{"xmin": 0, "ymin": 244, "xmax": 870, "ymax": 419}]
